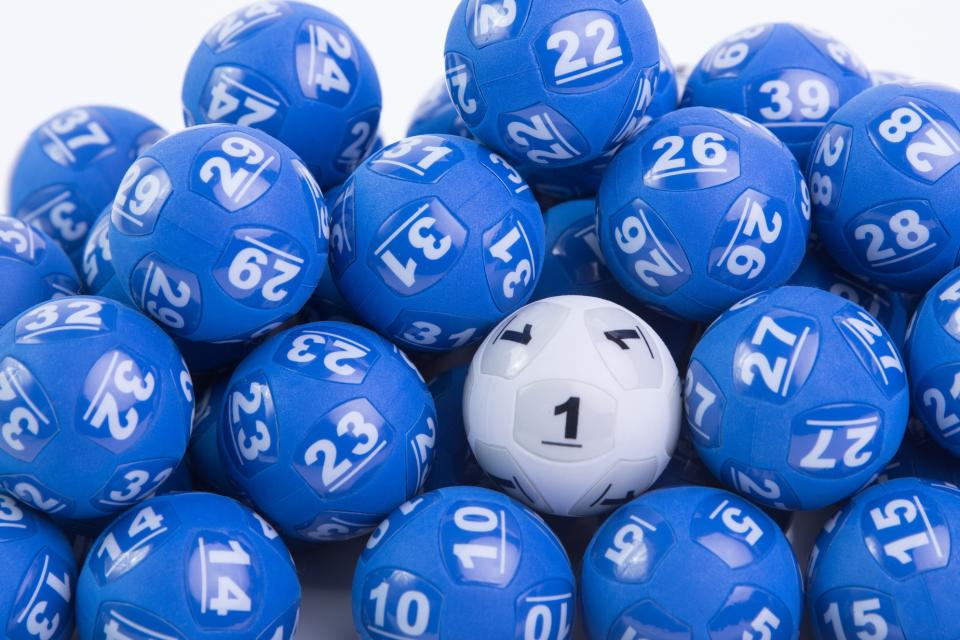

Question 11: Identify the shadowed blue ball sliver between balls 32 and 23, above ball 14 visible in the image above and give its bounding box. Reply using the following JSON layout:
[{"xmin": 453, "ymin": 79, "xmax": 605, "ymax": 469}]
[{"xmin": 187, "ymin": 378, "xmax": 240, "ymax": 498}]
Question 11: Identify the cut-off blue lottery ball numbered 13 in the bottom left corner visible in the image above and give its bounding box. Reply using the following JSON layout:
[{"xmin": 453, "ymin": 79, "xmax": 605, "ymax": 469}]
[{"xmin": 0, "ymin": 494, "xmax": 77, "ymax": 640}]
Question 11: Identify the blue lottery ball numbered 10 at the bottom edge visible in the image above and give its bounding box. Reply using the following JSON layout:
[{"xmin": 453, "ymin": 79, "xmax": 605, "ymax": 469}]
[{"xmin": 353, "ymin": 487, "xmax": 576, "ymax": 640}]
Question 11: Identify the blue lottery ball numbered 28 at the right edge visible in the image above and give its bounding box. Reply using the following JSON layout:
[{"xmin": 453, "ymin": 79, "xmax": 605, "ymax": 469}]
[{"xmin": 807, "ymin": 82, "xmax": 960, "ymax": 293}]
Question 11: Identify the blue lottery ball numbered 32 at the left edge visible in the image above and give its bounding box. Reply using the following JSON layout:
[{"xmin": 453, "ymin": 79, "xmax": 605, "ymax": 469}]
[{"xmin": 0, "ymin": 296, "xmax": 193, "ymax": 520}]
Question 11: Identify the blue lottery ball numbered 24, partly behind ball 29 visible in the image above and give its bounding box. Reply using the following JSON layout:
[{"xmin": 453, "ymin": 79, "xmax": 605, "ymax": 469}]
[{"xmin": 183, "ymin": 2, "xmax": 381, "ymax": 189}]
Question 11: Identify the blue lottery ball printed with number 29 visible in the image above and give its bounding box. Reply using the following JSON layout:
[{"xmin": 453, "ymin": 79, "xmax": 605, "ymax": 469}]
[{"xmin": 107, "ymin": 125, "xmax": 327, "ymax": 342}]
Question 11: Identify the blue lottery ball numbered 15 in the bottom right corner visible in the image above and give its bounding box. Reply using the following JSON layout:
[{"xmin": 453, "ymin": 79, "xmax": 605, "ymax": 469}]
[{"xmin": 807, "ymin": 478, "xmax": 960, "ymax": 640}]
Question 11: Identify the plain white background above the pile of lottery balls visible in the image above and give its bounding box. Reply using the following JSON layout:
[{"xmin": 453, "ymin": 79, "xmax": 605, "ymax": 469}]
[{"xmin": 0, "ymin": 0, "xmax": 960, "ymax": 208}]
